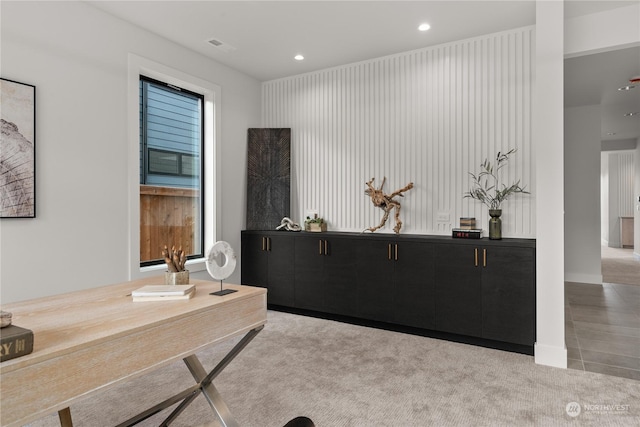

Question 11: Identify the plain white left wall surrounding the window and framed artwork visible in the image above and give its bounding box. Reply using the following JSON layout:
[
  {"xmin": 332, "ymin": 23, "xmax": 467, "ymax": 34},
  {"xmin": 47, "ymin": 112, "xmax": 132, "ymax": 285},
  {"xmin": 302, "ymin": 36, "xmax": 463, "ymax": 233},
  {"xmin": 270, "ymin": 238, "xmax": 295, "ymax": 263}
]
[{"xmin": 0, "ymin": 1, "xmax": 260, "ymax": 302}]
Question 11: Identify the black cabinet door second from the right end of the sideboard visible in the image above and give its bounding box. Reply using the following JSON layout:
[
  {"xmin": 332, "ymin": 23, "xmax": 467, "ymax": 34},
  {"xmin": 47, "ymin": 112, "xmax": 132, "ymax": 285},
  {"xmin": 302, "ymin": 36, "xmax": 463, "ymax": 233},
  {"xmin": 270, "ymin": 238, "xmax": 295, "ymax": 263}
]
[{"xmin": 435, "ymin": 244, "xmax": 482, "ymax": 337}]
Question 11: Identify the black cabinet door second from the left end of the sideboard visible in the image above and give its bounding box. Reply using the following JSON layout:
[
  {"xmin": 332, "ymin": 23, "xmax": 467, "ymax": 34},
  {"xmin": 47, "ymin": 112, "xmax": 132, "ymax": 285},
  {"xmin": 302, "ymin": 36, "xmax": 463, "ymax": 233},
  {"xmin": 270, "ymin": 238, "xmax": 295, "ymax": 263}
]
[{"xmin": 267, "ymin": 232, "xmax": 295, "ymax": 307}]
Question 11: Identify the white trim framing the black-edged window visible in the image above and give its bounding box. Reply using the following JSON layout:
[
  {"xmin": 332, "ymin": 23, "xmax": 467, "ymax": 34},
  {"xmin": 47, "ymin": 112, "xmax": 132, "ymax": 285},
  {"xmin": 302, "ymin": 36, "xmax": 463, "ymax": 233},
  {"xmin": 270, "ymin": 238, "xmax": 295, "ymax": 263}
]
[{"xmin": 127, "ymin": 53, "xmax": 222, "ymax": 280}]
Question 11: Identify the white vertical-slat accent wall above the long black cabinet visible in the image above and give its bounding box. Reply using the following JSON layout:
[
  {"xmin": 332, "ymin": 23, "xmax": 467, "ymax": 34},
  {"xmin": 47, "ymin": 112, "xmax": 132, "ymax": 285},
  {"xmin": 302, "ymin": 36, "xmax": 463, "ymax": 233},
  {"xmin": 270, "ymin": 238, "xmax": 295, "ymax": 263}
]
[{"xmin": 262, "ymin": 27, "xmax": 535, "ymax": 237}]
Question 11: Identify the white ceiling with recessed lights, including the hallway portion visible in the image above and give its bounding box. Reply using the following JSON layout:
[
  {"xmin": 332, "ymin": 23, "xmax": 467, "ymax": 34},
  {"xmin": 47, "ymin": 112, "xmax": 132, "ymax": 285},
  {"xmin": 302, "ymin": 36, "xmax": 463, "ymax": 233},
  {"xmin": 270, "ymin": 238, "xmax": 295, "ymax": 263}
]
[{"xmin": 86, "ymin": 0, "xmax": 640, "ymax": 139}]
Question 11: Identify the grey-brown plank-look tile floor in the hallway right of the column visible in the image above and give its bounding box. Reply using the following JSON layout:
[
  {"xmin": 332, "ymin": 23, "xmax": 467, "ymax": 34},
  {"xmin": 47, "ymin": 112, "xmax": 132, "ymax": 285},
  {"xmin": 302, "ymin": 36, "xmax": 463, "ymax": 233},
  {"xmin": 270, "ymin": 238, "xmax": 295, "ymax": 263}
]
[{"xmin": 564, "ymin": 282, "xmax": 640, "ymax": 381}]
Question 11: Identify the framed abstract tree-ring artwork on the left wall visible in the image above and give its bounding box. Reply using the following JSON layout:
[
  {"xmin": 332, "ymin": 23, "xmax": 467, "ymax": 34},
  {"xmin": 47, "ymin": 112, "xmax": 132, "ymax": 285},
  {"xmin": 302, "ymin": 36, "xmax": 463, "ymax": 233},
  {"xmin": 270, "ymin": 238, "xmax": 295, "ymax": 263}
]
[{"xmin": 0, "ymin": 78, "xmax": 36, "ymax": 218}]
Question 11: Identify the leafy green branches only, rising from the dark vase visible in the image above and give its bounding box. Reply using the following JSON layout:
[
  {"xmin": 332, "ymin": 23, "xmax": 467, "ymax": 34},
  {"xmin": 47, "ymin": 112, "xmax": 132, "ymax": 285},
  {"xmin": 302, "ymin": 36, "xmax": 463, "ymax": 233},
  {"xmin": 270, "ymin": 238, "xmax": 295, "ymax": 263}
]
[{"xmin": 464, "ymin": 148, "xmax": 530, "ymax": 209}]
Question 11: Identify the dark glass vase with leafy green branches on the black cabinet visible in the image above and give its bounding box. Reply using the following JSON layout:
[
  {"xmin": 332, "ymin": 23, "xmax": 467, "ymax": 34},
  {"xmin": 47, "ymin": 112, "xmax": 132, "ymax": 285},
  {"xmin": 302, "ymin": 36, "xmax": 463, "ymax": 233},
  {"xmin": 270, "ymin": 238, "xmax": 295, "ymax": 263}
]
[{"xmin": 464, "ymin": 148, "xmax": 529, "ymax": 240}]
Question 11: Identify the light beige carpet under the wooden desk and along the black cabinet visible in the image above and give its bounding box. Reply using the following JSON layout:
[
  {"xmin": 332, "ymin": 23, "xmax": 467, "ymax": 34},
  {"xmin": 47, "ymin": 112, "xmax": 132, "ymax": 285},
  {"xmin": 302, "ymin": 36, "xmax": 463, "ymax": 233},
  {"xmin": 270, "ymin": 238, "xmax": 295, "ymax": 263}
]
[{"xmin": 27, "ymin": 311, "xmax": 640, "ymax": 427}]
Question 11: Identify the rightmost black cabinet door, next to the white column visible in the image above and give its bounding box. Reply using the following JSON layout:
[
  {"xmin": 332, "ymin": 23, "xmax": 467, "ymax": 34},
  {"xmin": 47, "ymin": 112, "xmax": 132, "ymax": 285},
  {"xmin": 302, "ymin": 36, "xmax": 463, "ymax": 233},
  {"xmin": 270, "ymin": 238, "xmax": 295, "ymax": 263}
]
[{"xmin": 482, "ymin": 247, "xmax": 535, "ymax": 346}]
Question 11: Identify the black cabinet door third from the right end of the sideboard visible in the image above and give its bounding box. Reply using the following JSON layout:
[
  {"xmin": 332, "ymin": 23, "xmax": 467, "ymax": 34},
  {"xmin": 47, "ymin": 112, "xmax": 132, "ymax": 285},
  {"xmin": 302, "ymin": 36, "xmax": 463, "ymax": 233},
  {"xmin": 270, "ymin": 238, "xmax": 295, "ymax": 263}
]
[{"xmin": 393, "ymin": 242, "xmax": 435, "ymax": 329}]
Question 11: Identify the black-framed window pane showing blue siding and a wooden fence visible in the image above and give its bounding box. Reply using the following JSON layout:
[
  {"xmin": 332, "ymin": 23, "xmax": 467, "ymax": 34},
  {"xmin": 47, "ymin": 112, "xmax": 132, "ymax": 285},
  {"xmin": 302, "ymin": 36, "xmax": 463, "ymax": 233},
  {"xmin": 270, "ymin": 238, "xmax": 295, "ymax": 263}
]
[{"xmin": 139, "ymin": 76, "xmax": 205, "ymax": 266}]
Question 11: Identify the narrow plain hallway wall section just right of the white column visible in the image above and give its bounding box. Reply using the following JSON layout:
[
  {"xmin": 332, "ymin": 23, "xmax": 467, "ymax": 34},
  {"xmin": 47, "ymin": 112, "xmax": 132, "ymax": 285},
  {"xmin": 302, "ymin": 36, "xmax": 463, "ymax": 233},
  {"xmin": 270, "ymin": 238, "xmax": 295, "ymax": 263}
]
[{"xmin": 564, "ymin": 105, "xmax": 602, "ymax": 284}]
